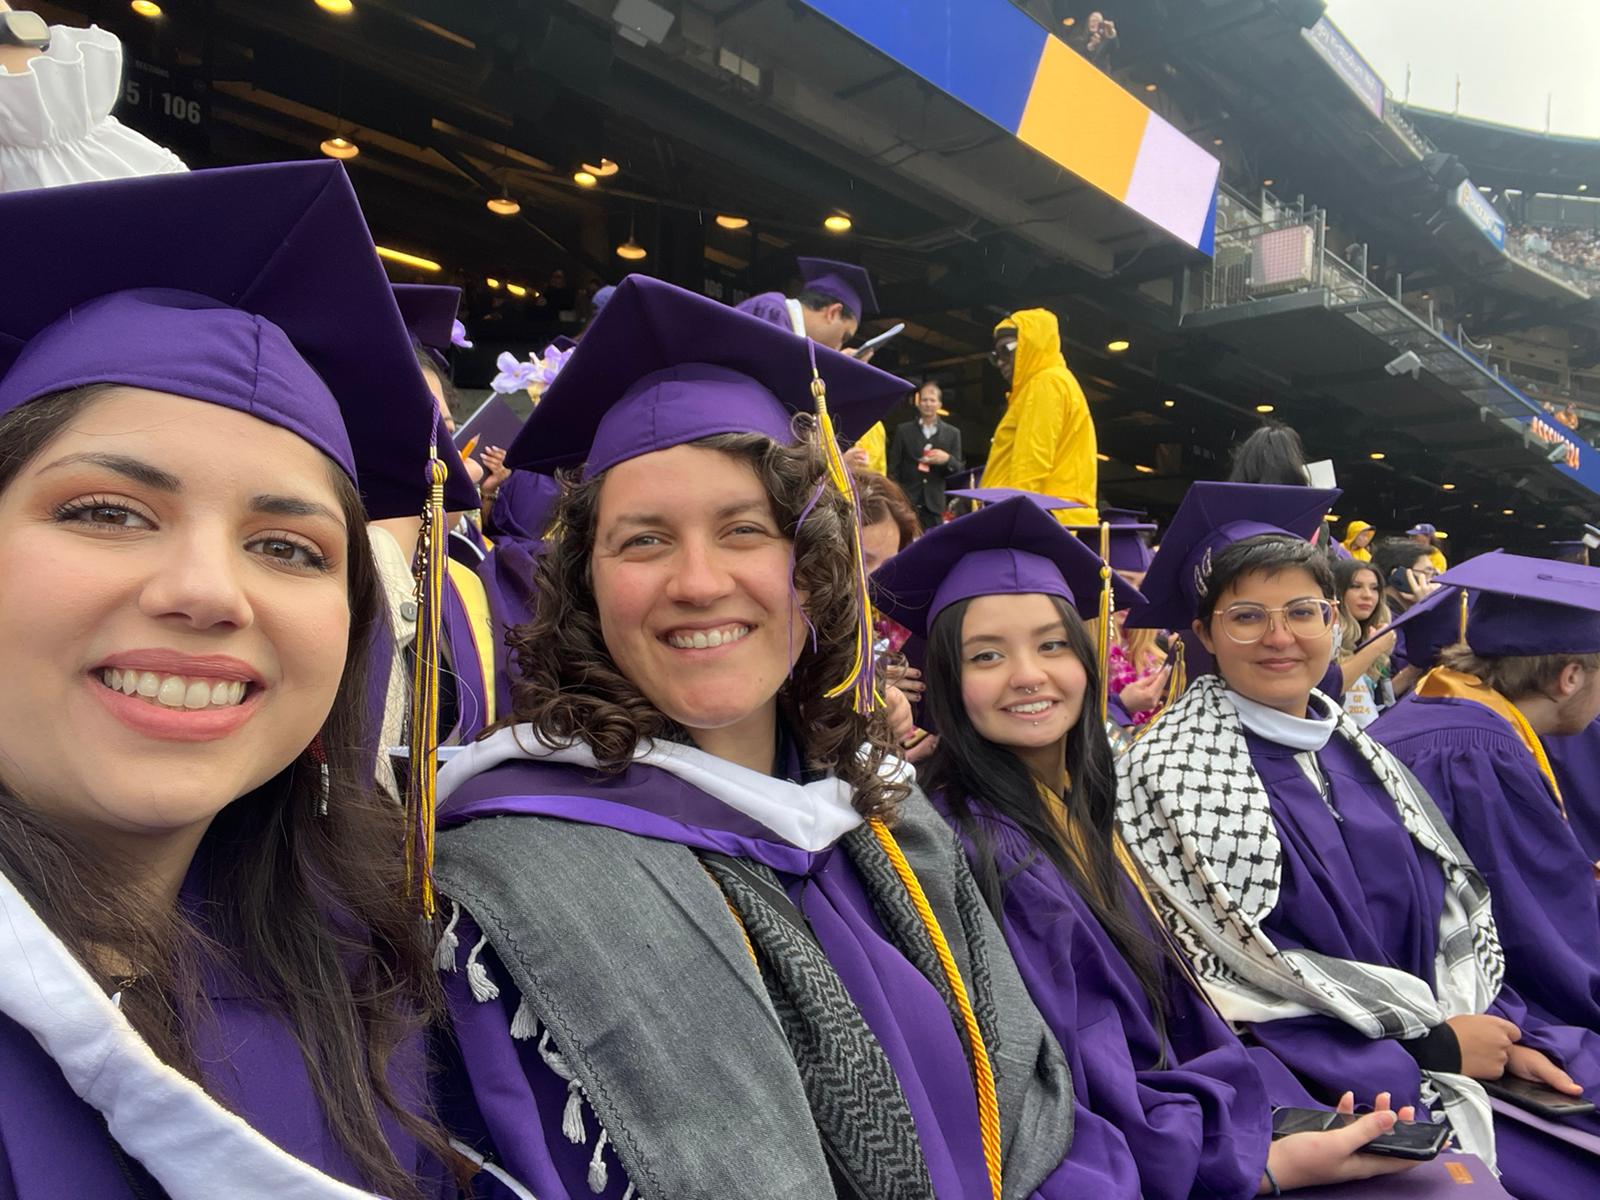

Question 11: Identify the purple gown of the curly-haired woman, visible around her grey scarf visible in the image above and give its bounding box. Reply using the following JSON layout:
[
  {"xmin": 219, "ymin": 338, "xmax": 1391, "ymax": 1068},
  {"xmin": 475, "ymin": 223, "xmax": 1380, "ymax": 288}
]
[{"xmin": 440, "ymin": 763, "xmax": 1082, "ymax": 1200}]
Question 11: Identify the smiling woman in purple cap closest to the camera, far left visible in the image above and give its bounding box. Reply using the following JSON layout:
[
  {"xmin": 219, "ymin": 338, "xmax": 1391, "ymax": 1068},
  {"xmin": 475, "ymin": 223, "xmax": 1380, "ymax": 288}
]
[{"xmin": 0, "ymin": 163, "xmax": 470, "ymax": 1200}]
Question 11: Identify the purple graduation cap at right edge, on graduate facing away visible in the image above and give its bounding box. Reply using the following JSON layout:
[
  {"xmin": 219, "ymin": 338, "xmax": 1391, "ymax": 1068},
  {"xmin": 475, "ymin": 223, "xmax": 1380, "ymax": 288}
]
[{"xmin": 1438, "ymin": 554, "xmax": 1600, "ymax": 658}]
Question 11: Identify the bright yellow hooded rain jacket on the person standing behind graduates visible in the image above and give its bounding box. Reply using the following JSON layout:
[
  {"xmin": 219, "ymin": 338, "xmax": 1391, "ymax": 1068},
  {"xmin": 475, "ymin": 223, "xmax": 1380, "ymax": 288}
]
[{"xmin": 982, "ymin": 309, "xmax": 1099, "ymax": 525}]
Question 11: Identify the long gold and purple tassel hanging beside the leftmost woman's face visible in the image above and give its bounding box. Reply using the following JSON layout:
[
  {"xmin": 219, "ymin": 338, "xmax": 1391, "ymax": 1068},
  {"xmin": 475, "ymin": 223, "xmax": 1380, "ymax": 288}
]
[{"xmin": 406, "ymin": 453, "xmax": 448, "ymax": 918}]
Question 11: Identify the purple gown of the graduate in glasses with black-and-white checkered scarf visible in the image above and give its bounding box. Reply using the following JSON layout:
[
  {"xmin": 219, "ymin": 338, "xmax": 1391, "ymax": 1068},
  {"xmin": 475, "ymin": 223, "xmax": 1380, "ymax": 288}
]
[{"xmin": 1245, "ymin": 731, "xmax": 1600, "ymax": 1200}]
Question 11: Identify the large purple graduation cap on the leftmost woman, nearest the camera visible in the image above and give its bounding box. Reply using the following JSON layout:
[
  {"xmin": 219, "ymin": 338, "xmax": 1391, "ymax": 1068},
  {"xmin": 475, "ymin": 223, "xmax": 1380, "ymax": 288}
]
[{"xmin": 0, "ymin": 162, "xmax": 477, "ymax": 518}]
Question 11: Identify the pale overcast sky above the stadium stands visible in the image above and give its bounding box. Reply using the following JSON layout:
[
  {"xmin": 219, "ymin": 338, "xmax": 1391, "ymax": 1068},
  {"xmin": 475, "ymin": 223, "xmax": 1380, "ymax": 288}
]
[{"xmin": 1328, "ymin": 0, "xmax": 1600, "ymax": 138}]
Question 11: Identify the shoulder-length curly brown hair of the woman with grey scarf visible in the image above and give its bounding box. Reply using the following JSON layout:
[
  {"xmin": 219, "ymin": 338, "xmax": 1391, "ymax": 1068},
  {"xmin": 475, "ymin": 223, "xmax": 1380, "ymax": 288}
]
[{"xmin": 502, "ymin": 424, "xmax": 909, "ymax": 816}]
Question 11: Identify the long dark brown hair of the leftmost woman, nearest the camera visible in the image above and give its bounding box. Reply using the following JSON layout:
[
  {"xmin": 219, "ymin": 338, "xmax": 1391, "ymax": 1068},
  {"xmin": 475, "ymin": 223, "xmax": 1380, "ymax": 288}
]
[{"xmin": 0, "ymin": 386, "xmax": 459, "ymax": 1198}]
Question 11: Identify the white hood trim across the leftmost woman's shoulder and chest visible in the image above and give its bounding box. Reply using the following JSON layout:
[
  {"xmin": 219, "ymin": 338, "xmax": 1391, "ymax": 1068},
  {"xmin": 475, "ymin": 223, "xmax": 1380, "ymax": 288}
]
[{"xmin": 0, "ymin": 874, "xmax": 379, "ymax": 1200}]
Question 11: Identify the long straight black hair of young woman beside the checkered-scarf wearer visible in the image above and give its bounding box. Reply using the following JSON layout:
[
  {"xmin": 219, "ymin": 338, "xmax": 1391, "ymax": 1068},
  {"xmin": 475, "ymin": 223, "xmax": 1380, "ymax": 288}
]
[{"xmin": 925, "ymin": 597, "xmax": 1166, "ymax": 1042}]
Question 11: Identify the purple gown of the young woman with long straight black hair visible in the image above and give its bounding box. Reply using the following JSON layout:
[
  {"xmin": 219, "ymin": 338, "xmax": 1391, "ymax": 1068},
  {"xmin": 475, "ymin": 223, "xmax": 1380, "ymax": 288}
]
[{"xmin": 934, "ymin": 798, "xmax": 1280, "ymax": 1200}]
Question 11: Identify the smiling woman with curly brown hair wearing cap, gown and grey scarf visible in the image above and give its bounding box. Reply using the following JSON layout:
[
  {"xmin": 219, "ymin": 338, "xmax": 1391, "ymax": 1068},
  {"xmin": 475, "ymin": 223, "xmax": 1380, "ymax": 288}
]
[{"xmin": 437, "ymin": 277, "xmax": 1072, "ymax": 1200}]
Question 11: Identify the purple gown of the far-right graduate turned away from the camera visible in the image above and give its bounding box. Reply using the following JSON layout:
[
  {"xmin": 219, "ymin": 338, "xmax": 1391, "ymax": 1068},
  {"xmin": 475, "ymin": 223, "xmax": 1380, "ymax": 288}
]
[{"xmin": 1371, "ymin": 694, "xmax": 1600, "ymax": 1036}]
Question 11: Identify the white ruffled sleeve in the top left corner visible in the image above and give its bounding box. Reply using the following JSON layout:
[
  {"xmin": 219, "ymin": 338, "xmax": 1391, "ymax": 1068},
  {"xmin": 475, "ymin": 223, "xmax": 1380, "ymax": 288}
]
[{"xmin": 0, "ymin": 26, "xmax": 189, "ymax": 192}]
